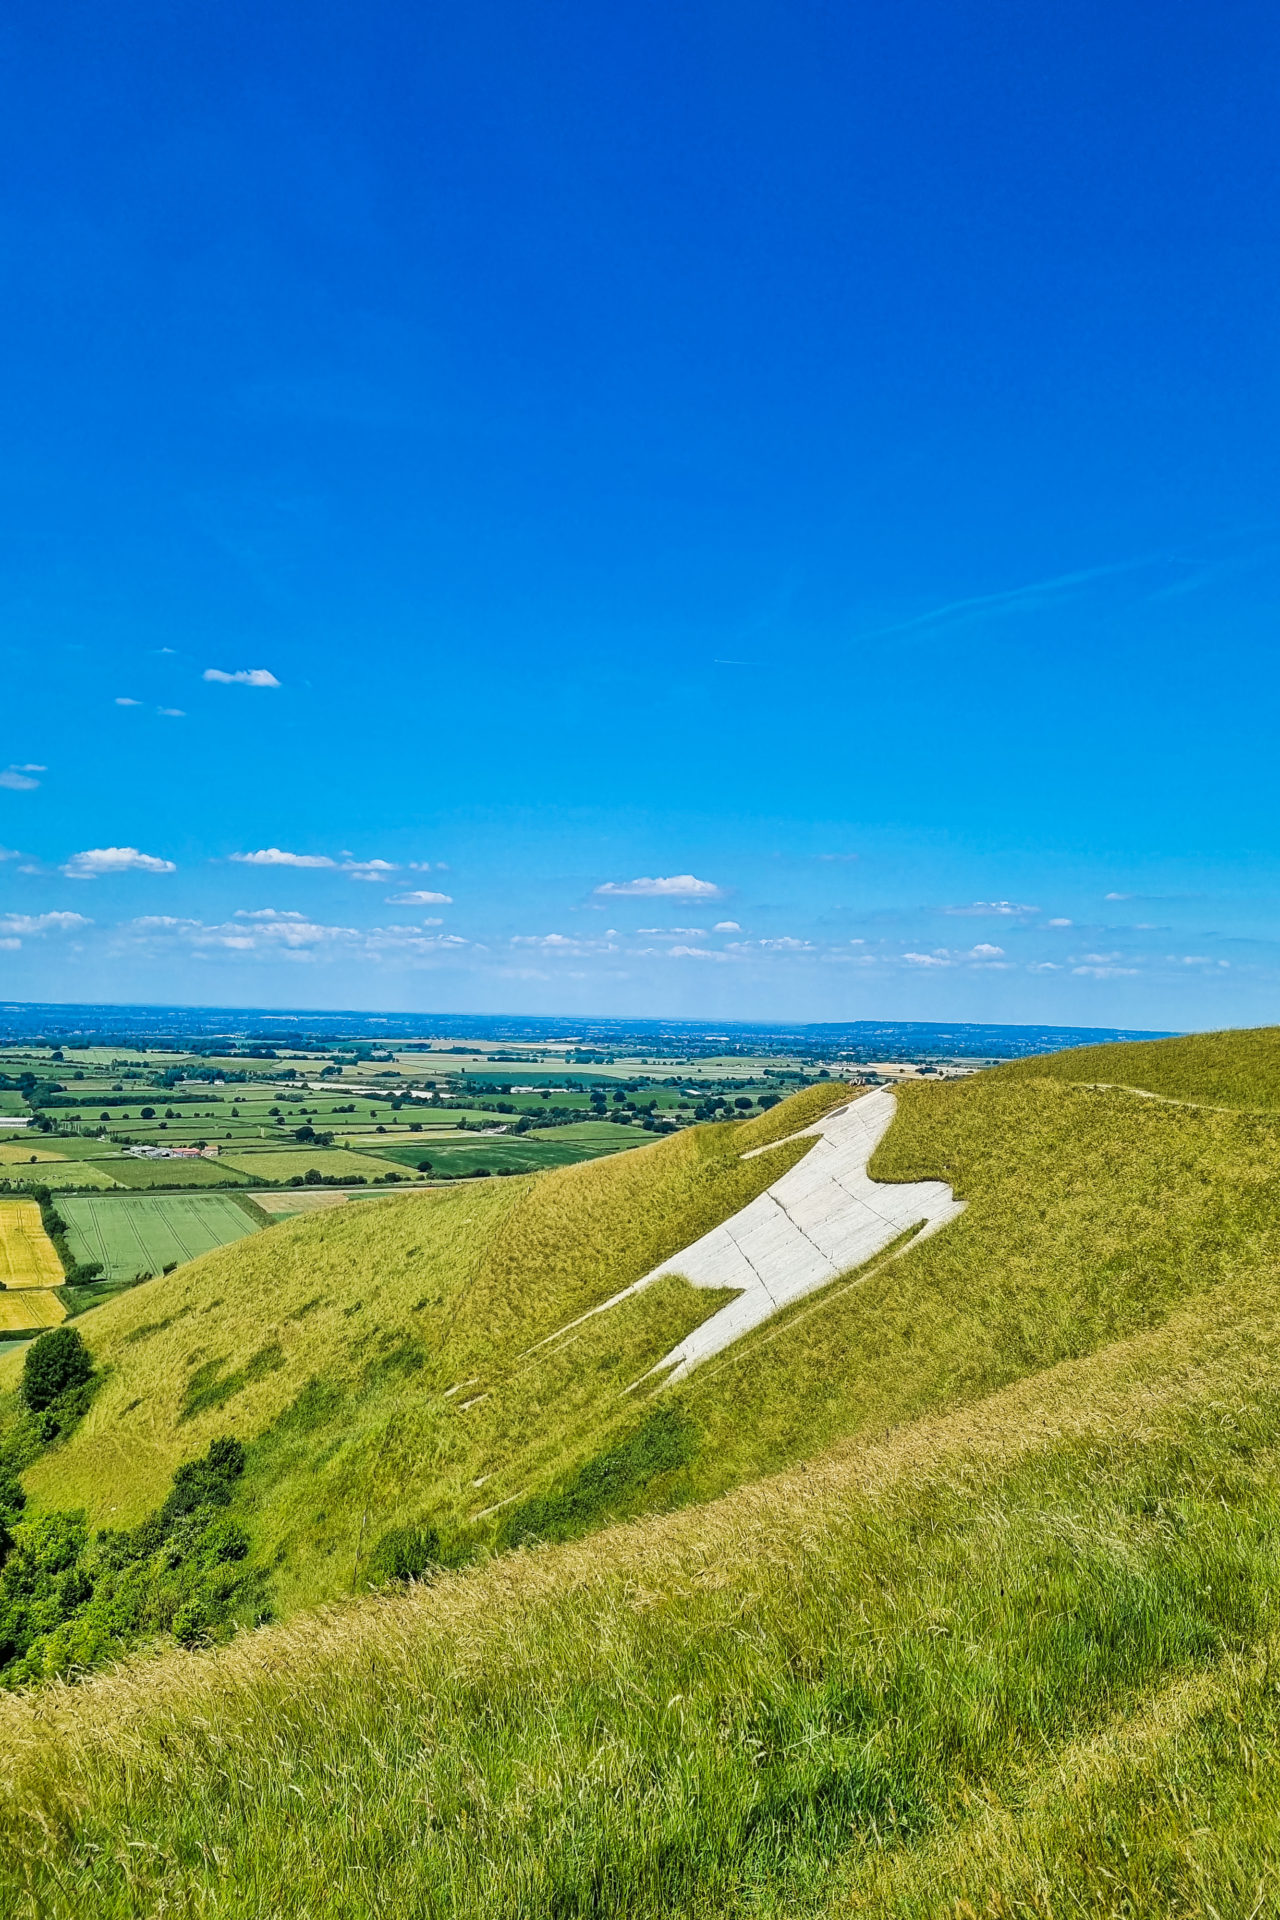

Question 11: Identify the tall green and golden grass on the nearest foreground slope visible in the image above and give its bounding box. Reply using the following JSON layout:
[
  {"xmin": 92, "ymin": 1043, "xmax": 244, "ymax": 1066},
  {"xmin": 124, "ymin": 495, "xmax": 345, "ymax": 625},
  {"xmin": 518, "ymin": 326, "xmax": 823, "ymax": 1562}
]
[{"xmin": 0, "ymin": 1265, "xmax": 1280, "ymax": 1920}]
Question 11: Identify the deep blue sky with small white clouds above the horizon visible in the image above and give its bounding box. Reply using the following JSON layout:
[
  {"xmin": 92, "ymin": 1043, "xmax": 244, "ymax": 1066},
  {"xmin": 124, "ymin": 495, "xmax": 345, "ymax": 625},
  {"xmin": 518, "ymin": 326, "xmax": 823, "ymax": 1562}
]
[{"xmin": 0, "ymin": 0, "xmax": 1280, "ymax": 1027}]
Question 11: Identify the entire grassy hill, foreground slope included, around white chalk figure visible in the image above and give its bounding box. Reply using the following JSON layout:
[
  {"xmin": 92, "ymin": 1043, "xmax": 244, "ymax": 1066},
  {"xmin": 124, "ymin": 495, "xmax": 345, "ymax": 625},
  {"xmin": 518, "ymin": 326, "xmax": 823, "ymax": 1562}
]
[{"xmin": 0, "ymin": 1031, "xmax": 1280, "ymax": 1920}]
